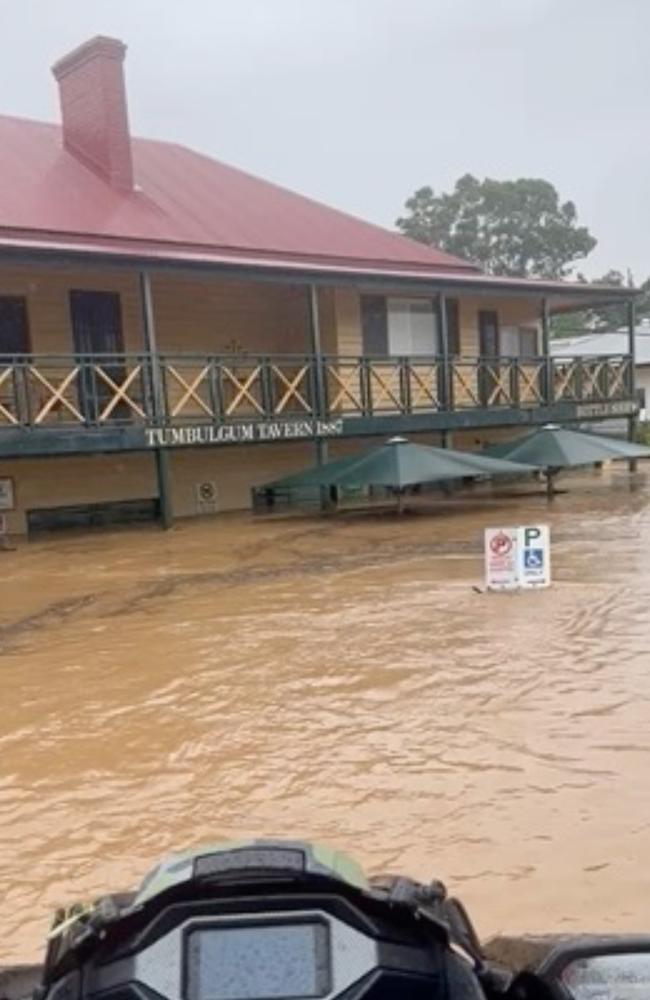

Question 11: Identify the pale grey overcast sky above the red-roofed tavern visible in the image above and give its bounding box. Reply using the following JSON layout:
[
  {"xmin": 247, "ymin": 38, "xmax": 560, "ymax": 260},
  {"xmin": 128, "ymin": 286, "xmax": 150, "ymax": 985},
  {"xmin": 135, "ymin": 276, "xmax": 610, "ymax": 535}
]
[{"xmin": 0, "ymin": 0, "xmax": 650, "ymax": 281}]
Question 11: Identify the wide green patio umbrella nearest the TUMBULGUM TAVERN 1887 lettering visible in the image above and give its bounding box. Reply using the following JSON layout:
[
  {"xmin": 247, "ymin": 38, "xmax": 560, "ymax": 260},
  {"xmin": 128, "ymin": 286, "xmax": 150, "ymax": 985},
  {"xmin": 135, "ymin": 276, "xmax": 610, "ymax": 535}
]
[{"xmin": 264, "ymin": 438, "xmax": 533, "ymax": 512}]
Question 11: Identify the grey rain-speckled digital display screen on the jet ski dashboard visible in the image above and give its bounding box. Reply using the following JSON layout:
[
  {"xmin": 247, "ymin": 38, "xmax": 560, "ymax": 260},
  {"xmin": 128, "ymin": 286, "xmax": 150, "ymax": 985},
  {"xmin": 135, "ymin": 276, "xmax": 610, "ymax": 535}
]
[{"xmin": 188, "ymin": 921, "xmax": 330, "ymax": 1000}]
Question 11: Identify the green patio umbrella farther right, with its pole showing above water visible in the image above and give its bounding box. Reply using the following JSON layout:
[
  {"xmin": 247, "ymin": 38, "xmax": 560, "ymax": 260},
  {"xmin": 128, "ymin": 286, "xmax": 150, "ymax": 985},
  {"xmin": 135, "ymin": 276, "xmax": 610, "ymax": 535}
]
[{"xmin": 485, "ymin": 424, "xmax": 650, "ymax": 495}]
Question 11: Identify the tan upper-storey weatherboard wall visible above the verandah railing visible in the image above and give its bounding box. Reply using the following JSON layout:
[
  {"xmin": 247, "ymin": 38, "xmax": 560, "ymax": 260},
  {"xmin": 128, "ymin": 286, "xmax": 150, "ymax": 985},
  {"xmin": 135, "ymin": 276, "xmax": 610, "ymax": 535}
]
[{"xmin": 0, "ymin": 266, "xmax": 540, "ymax": 357}]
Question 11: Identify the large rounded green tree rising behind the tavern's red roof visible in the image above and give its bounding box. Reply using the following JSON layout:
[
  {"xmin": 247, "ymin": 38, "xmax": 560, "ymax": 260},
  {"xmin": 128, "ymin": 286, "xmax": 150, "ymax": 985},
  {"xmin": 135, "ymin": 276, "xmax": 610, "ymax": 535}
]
[{"xmin": 397, "ymin": 174, "xmax": 596, "ymax": 278}]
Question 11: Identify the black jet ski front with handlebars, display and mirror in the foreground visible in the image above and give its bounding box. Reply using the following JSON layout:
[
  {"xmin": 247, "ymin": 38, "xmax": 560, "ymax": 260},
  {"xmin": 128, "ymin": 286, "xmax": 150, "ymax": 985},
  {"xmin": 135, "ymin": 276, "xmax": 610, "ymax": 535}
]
[{"xmin": 0, "ymin": 840, "xmax": 650, "ymax": 1000}]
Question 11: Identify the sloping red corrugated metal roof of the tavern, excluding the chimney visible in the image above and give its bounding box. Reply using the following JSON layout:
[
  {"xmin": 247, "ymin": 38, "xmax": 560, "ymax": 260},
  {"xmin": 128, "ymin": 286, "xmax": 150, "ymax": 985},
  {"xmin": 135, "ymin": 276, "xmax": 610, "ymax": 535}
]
[{"xmin": 0, "ymin": 116, "xmax": 480, "ymax": 275}]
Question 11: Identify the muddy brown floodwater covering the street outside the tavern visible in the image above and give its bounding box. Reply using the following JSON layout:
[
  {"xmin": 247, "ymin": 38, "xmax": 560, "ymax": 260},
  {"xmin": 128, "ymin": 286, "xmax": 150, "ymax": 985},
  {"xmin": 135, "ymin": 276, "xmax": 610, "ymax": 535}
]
[{"xmin": 0, "ymin": 469, "xmax": 650, "ymax": 961}]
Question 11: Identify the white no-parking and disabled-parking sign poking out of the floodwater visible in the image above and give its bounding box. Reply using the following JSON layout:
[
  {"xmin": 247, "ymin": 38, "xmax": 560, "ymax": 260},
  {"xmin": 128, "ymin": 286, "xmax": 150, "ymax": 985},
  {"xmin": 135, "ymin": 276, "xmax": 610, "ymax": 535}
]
[{"xmin": 485, "ymin": 524, "xmax": 551, "ymax": 590}]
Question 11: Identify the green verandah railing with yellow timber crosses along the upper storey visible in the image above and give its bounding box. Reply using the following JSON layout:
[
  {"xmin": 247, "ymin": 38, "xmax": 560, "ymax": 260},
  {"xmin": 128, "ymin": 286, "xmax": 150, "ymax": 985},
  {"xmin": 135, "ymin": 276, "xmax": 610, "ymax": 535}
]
[{"xmin": 0, "ymin": 354, "xmax": 632, "ymax": 432}]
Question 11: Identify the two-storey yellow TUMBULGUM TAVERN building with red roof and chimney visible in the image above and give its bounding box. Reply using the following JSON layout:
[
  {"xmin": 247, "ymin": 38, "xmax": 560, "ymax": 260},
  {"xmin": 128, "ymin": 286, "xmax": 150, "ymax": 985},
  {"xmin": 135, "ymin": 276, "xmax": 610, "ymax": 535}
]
[{"xmin": 0, "ymin": 37, "xmax": 636, "ymax": 534}]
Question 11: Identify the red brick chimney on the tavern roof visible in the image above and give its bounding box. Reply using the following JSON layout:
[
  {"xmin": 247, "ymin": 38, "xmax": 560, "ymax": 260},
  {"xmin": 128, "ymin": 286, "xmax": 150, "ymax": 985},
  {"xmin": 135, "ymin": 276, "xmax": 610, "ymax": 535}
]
[{"xmin": 52, "ymin": 35, "xmax": 133, "ymax": 191}]
